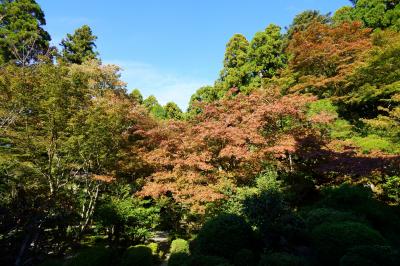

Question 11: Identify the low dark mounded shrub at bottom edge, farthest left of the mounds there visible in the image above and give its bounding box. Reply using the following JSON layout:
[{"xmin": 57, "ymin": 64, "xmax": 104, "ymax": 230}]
[{"xmin": 67, "ymin": 247, "xmax": 113, "ymax": 266}]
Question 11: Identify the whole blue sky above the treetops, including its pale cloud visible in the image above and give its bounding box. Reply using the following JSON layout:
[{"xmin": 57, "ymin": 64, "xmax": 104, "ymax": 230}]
[{"xmin": 37, "ymin": 0, "xmax": 349, "ymax": 109}]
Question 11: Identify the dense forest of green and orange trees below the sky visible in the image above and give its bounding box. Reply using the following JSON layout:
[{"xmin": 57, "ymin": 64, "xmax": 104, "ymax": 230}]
[{"xmin": 0, "ymin": 0, "xmax": 400, "ymax": 266}]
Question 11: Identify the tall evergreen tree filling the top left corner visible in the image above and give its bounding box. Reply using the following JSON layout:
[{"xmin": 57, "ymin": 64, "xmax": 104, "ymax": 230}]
[{"xmin": 0, "ymin": 0, "xmax": 51, "ymax": 65}]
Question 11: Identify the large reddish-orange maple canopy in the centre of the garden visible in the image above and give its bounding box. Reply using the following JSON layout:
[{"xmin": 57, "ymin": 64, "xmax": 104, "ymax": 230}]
[{"xmin": 131, "ymin": 91, "xmax": 314, "ymax": 212}]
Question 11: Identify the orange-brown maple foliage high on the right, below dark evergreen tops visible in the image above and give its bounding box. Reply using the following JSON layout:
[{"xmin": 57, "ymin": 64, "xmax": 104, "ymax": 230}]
[{"xmin": 288, "ymin": 22, "xmax": 372, "ymax": 95}]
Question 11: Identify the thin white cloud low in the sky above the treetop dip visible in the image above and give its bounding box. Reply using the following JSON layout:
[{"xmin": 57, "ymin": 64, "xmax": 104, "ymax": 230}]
[{"xmin": 105, "ymin": 61, "xmax": 213, "ymax": 110}]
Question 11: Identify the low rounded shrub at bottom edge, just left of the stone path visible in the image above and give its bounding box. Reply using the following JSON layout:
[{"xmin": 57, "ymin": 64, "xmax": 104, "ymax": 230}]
[{"xmin": 121, "ymin": 245, "xmax": 153, "ymax": 266}]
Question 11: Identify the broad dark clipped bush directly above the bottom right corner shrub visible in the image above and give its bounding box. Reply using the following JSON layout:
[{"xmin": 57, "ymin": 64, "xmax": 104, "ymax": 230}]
[{"xmin": 312, "ymin": 222, "xmax": 386, "ymax": 265}]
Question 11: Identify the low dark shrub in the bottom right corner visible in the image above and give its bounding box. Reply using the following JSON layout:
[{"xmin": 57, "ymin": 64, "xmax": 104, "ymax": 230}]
[{"xmin": 340, "ymin": 246, "xmax": 400, "ymax": 266}]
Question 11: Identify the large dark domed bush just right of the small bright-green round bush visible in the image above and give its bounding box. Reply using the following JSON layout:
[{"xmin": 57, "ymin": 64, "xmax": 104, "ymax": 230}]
[{"xmin": 194, "ymin": 214, "xmax": 255, "ymax": 260}]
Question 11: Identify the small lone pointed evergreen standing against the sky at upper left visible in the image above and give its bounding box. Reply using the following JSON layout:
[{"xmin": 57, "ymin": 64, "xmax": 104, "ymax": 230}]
[{"xmin": 61, "ymin": 25, "xmax": 98, "ymax": 64}]
